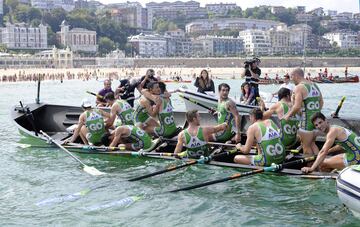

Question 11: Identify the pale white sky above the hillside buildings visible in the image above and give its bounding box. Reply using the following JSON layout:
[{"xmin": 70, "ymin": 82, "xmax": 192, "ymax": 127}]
[{"xmin": 99, "ymin": 0, "xmax": 360, "ymax": 13}]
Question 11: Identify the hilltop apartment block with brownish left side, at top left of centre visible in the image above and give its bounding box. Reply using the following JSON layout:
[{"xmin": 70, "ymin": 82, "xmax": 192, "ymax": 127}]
[{"xmin": 109, "ymin": 2, "xmax": 153, "ymax": 29}]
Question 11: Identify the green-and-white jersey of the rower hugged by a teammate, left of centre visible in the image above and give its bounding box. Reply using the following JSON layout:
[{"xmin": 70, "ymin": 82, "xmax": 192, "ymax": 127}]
[{"xmin": 155, "ymin": 98, "xmax": 176, "ymax": 137}]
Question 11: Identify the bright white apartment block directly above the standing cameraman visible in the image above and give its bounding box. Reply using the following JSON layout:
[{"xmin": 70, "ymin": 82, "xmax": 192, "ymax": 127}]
[{"xmin": 239, "ymin": 29, "xmax": 272, "ymax": 56}]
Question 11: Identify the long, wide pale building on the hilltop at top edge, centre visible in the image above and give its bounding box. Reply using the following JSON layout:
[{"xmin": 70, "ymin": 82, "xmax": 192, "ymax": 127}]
[{"xmin": 146, "ymin": 1, "xmax": 208, "ymax": 20}]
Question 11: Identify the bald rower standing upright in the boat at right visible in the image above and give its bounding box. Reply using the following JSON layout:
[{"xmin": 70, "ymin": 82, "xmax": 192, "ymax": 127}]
[{"xmin": 284, "ymin": 68, "xmax": 324, "ymax": 155}]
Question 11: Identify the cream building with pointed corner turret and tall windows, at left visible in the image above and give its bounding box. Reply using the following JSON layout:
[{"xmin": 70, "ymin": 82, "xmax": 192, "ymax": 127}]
[{"xmin": 57, "ymin": 21, "xmax": 97, "ymax": 53}]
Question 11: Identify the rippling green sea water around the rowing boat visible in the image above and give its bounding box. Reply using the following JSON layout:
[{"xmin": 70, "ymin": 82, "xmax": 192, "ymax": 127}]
[{"xmin": 0, "ymin": 80, "xmax": 360, "ymax": 226}]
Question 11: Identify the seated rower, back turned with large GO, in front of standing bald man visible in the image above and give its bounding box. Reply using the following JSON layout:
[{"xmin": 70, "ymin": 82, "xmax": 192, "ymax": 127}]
[{"xmin": 234, "ymin": 108, "xmax": 285, "ymax": 166}]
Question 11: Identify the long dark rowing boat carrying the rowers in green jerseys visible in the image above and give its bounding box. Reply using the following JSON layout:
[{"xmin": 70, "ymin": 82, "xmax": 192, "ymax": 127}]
[{"xmin": 11, "ymin": 103, "xmax": 360, "ymax": 178}]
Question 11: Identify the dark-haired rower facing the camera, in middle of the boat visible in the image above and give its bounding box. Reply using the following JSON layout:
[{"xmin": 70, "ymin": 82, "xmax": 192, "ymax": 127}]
[{"xmin": 212, "ymin": 83, "xmax": 241, "ymax": 143}]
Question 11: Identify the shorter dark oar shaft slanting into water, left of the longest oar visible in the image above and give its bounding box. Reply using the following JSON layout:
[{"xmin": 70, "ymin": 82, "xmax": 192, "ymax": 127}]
[{"xmin": 129, "ymin": 149, "xmax": 238, "ymax": 181}]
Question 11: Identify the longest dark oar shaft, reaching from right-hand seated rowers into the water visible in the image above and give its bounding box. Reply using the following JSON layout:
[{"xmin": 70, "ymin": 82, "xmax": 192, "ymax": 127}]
[{"xmin": 169, "ymin": 156, "xmax": 315, "ymax": 192}]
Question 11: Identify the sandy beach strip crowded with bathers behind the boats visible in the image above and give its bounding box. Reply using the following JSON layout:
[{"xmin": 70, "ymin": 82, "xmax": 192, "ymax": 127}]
[{"xmin": 0, "ymin": 65, "xmax": 360, "ymax": 83}]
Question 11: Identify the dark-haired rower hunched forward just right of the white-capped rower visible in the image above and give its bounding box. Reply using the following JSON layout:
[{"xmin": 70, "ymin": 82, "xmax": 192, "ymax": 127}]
[{"xmin": 104, "ymin": 92, "xmax": 134, "ymax": 127}]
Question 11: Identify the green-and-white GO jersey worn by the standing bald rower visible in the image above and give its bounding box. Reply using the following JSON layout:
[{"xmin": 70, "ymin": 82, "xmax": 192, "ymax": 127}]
[{"xmin": 300, "ymin": 83, "xmax": 321, "ymax": 131}]
